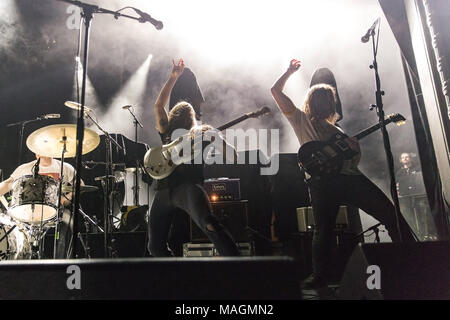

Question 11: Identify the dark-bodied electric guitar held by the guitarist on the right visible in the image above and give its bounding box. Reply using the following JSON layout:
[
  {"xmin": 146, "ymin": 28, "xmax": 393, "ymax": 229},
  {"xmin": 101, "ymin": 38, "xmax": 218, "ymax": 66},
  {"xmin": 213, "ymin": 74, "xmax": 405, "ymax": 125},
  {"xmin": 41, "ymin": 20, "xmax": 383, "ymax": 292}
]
[{"xmin": 297, "ymin": 113, "xmax": 406, "ymax": 176}]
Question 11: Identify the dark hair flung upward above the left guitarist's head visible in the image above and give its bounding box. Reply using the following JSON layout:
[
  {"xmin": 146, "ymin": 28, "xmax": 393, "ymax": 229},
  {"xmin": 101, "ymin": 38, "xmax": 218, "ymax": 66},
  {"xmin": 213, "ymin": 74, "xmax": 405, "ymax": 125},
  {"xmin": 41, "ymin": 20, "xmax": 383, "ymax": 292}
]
[{"xmin": 169, "ymin": 68, "xmax": 205, "ymax": 120}]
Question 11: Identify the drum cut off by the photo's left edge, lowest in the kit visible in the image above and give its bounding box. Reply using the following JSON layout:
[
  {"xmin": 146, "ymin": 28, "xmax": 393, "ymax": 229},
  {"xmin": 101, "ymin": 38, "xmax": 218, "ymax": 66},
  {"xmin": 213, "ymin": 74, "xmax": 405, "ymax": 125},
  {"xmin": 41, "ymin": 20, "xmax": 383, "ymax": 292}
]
[{"xmin": 0, "ymin": 213, "xmax": 31, "ymax": 260}]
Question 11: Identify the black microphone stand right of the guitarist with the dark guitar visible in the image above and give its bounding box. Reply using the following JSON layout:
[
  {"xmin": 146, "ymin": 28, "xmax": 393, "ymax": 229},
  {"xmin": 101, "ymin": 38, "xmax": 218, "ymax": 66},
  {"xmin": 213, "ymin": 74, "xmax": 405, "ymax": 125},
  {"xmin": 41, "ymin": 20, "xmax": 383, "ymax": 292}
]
[{"xmin": 369, "ymin": 25, "xmax": 403, "ymax": 242}]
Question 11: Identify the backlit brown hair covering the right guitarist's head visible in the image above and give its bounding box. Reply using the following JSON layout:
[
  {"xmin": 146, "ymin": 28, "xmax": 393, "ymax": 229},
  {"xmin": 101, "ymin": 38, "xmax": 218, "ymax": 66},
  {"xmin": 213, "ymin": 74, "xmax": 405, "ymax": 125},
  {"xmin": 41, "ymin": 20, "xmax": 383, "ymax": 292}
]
[{"xmin": 303, "ymin": 83, "xmax": 339, "ymax": 124}]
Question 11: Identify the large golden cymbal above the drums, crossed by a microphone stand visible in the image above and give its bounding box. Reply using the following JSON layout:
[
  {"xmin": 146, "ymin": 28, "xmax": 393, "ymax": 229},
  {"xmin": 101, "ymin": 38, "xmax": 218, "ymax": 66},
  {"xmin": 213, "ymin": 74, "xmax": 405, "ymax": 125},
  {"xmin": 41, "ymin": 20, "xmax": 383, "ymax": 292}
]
[{"xmin": 27, "ymin": 124, "xmax": 100, "ymax": 158}]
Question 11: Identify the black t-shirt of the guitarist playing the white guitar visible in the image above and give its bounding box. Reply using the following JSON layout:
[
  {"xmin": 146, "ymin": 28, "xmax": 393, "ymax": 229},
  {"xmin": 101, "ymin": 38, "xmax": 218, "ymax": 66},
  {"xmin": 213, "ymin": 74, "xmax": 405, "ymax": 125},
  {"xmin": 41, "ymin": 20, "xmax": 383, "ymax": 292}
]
[{"xmin": 157, "ymin": 133, "xmax": 209, "ymax": 190}]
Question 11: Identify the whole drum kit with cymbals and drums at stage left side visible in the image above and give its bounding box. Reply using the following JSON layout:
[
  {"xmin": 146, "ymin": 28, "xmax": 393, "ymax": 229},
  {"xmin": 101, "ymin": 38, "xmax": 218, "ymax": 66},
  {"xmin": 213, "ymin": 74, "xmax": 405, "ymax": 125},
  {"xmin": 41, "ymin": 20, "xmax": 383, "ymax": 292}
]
[{"xmin": 0, "ymin": 101, "xmax": 149, "ymax": 260}]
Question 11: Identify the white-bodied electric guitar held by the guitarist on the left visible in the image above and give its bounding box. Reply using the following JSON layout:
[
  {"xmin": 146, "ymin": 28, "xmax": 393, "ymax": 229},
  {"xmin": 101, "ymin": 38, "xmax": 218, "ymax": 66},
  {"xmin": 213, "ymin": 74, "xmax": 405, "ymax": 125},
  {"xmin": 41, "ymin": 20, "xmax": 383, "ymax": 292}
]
[{"xmin": 144, "ymin": 107, "xmax": 270, "ymax": 180}]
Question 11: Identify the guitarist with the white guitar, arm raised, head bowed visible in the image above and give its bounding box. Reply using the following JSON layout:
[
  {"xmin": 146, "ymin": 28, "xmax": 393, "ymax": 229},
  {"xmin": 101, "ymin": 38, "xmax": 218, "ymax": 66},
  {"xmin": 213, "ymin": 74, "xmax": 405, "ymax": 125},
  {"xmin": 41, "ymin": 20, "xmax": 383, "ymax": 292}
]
[{"xmin": 148, "ymin": 59, "xmax": 239, "ymax": 257}]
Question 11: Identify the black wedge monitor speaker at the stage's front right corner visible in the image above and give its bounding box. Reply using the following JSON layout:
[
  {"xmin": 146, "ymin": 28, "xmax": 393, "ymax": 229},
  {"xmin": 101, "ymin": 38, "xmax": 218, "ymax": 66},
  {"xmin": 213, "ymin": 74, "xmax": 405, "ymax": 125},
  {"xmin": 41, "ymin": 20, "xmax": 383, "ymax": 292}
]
[{"xmin": 338, "ymin": 242, "xmax": 450, "ymax": 300}]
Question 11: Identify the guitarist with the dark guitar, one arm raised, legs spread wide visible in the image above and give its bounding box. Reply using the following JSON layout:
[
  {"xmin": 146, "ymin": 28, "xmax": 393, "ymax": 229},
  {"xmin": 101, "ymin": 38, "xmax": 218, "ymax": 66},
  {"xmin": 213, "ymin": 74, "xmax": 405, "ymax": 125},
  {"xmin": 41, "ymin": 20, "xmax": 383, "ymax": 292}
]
[{"xmin": 271, "ymin": 59, "xmax": 414, "ymax": 288}]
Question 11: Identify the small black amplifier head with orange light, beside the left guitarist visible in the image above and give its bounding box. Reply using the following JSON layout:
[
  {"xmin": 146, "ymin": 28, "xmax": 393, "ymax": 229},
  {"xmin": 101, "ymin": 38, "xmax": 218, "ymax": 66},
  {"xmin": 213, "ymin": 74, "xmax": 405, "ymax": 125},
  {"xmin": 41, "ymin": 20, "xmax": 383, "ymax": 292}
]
[{"xmin": 203, "ymin": 178, "xmax": 241, "ymax": 202}]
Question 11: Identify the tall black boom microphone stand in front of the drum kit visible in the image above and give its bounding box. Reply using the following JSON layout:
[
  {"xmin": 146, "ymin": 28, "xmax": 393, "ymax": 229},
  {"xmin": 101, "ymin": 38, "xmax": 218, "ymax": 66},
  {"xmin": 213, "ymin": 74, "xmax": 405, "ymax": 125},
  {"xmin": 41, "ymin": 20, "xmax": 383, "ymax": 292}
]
[{"xmin": 57, "ymin": 0, "xmax": 160, "ymax": 257}]
